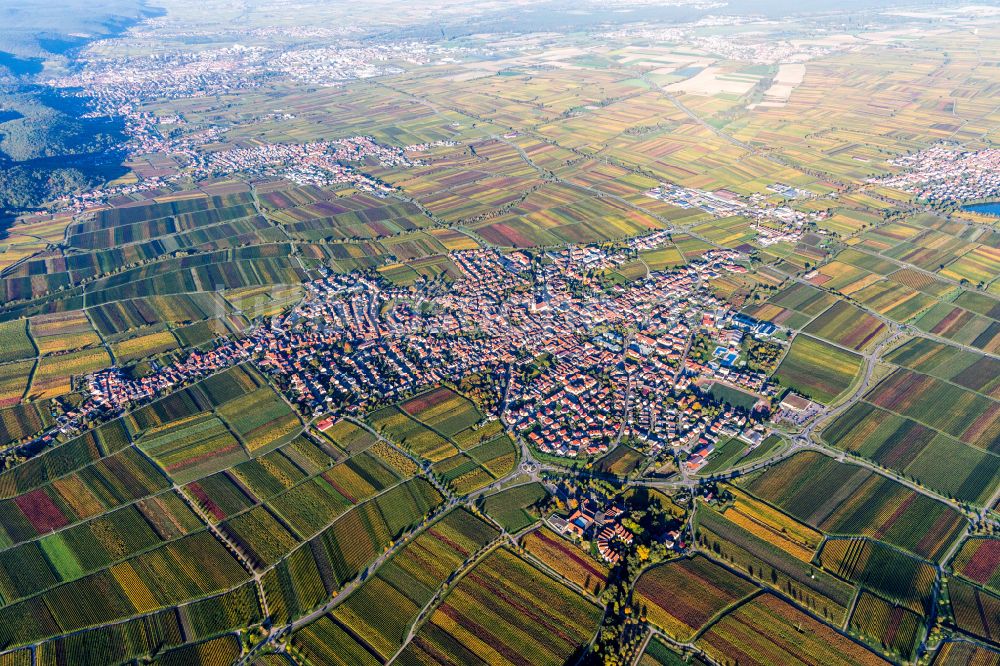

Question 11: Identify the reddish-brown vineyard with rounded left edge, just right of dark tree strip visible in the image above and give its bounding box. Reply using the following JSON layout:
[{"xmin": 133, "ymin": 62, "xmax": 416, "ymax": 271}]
[{"xmin": 633, "ymin": 556, "xmax": 760, "ymax": 643}]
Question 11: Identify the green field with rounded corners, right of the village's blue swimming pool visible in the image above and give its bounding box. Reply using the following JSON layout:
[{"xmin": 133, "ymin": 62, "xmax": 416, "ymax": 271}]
[{"xmin": 774, "ymin": 334, "xmax": 864, "ymax": 404}]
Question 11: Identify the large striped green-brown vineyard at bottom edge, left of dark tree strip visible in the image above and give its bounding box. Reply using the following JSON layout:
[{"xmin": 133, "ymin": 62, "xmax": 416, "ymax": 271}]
[{"xmin": 399, "ymin": 548, "xmax": 601, "ymax": 665}]
